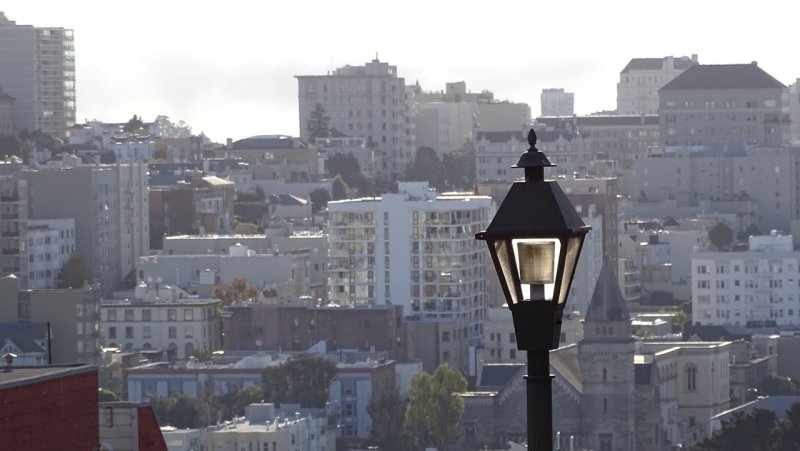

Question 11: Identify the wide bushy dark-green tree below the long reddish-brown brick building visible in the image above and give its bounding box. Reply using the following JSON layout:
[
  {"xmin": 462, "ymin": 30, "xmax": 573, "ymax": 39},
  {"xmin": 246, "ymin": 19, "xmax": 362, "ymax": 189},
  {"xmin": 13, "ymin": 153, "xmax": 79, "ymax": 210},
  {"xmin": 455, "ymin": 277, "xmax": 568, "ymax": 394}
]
[{"xmin": 262, "ymin": 354, "xmax": 338, "ymax": 407}]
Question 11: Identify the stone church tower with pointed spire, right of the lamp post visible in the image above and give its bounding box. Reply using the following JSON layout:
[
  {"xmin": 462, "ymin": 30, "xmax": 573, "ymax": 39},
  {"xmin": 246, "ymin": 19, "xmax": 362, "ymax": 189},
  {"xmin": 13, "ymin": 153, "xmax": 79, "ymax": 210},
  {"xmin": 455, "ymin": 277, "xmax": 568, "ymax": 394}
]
[{"xmin": 578, "ymin": 259, "xmax": 636, "ymax": 451}]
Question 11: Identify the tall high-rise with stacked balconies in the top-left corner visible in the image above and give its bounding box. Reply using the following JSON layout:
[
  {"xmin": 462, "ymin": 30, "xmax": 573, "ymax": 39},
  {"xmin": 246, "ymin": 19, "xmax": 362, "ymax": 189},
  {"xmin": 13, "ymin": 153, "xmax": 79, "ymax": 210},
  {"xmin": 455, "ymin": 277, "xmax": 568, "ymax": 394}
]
[{"xmin": 0, "ymin": 12, "xmax": 75, "ymax": 138}]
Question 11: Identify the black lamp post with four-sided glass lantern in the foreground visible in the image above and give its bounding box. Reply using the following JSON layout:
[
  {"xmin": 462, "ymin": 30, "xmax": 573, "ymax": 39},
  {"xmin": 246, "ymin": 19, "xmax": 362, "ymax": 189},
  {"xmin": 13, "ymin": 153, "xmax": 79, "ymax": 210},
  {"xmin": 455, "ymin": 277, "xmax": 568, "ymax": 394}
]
[{"xmin": 475, "ymin": 130, "xmax": 590, "ymax": 451}]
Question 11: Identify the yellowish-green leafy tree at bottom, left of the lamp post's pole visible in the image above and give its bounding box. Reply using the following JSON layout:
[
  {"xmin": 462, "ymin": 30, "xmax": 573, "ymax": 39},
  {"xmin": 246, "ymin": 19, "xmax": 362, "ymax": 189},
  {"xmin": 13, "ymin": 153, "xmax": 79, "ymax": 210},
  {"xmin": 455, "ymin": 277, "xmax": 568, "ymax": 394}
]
[{"xmin": 404, "ymin": 365, "xmax": 467, "ymax": 448}]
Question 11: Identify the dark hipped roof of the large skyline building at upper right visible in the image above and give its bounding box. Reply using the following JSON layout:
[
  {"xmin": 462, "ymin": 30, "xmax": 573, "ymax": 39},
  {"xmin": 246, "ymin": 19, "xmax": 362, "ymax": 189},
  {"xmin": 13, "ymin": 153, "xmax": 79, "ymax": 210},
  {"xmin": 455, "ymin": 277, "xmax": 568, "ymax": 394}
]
[{"xmin": 660, "ymin": 62, "xmax": 786, "ymax": 91}]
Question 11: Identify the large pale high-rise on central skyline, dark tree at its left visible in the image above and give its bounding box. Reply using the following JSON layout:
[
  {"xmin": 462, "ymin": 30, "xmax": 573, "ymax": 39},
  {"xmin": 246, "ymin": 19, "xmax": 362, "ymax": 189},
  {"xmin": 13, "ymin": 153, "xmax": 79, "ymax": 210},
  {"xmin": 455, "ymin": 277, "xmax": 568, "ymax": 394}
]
[{"xmin": 296, "ymin": 57, "xmax": 416, "ymax": 179}]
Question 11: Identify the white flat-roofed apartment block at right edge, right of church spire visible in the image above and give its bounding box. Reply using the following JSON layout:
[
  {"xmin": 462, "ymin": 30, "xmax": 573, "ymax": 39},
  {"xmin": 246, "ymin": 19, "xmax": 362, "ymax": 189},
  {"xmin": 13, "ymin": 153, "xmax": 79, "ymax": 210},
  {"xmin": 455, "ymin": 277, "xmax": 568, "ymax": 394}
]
[{"xmin": 692, "ymin": 233, "xmax": 800, "ymax": 327}]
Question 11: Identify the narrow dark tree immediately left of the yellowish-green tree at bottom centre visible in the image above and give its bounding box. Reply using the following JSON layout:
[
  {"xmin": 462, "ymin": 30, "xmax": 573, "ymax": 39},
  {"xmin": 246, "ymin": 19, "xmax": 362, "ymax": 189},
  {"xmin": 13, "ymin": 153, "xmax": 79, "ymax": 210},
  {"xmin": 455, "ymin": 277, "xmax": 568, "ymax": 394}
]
[{"xmin": 367, "ymin": 386, "xmax": 410, "ymax": 451}]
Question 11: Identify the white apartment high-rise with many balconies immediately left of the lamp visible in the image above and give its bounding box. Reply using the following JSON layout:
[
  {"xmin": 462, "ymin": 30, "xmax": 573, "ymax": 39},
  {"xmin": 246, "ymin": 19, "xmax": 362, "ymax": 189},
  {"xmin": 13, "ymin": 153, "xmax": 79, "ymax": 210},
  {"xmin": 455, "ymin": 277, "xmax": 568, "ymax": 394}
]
[{"xmin": 328, "ymin": 182, "xmax": 491, "ymax": 369}]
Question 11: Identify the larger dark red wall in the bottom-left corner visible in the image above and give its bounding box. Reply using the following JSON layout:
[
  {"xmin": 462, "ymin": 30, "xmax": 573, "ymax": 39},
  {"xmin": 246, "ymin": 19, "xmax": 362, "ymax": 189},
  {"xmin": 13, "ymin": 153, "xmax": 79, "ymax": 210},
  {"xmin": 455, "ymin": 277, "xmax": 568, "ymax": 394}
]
[{"xmin": 0, "ymin": 371, "xmax": 99, "ymax": 451}]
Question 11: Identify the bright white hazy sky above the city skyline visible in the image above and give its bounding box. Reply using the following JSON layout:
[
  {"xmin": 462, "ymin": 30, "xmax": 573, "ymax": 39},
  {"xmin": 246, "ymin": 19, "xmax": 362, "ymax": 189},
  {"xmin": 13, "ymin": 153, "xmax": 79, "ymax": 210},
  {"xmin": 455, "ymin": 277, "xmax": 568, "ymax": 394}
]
[{"xmin": 0, "ymin": 0, "xmax": 800, "ymax": 141}]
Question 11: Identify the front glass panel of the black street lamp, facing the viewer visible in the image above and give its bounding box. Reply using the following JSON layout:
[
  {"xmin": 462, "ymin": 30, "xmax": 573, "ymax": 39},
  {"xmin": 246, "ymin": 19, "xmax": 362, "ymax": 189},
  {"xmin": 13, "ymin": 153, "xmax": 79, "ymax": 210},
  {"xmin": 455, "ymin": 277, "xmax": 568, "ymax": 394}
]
[{"xmin": 511, "ymin": 238, "xmax": 561, "ymax": 300}]
